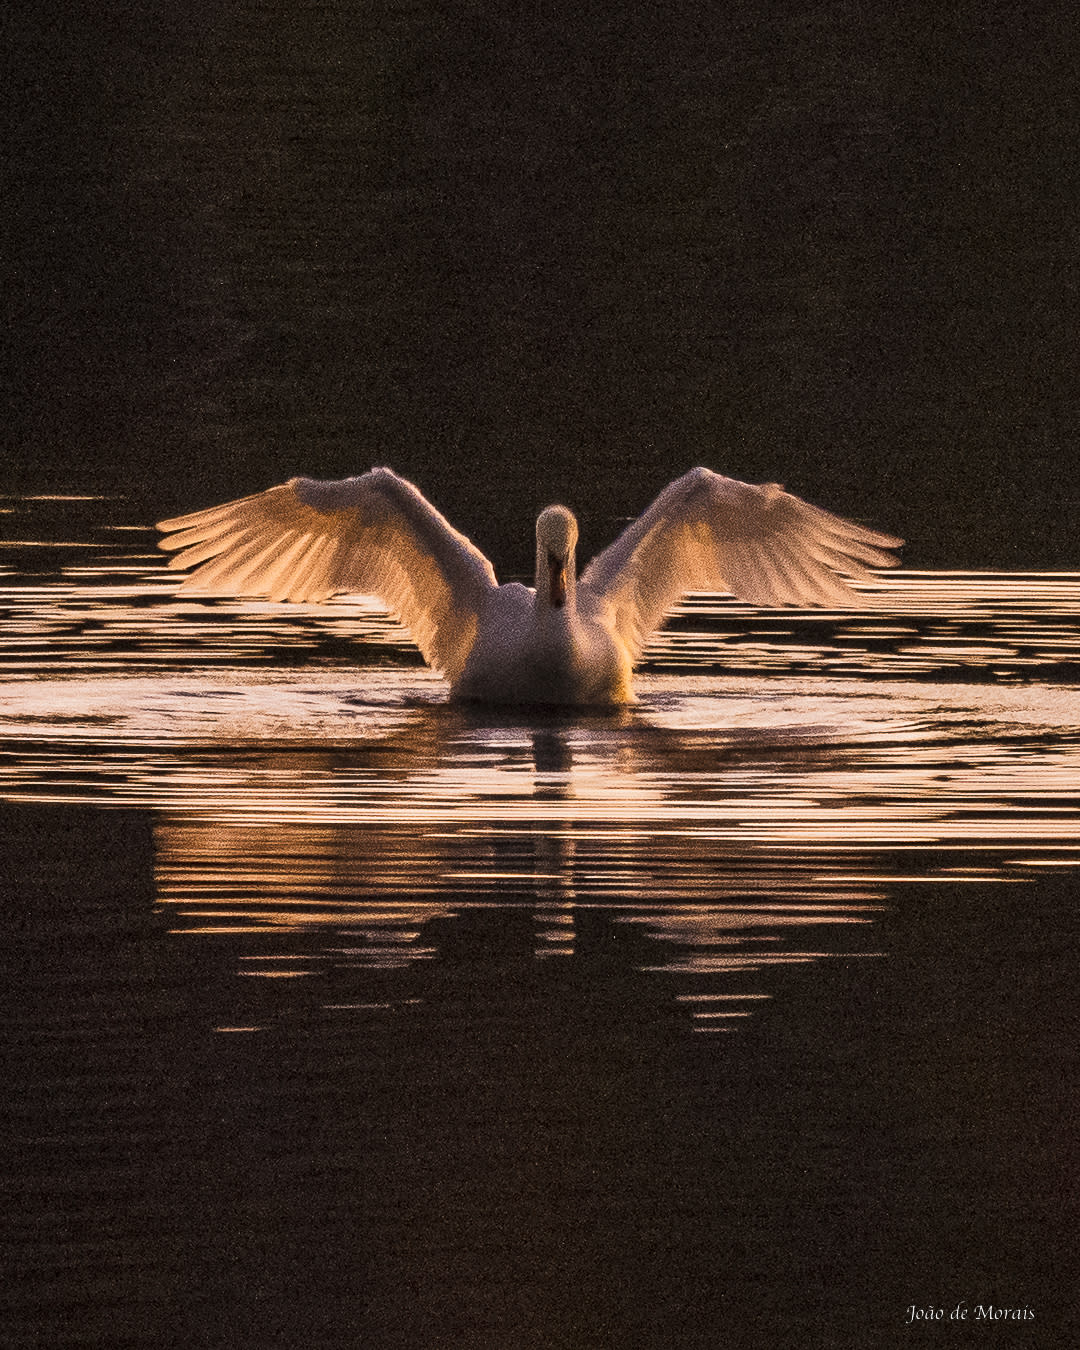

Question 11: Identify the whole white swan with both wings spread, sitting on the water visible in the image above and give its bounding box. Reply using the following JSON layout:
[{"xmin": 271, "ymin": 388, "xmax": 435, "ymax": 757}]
[{"xmin": 158, "ymin": 468, "xmax": 902, "ymax": 706}]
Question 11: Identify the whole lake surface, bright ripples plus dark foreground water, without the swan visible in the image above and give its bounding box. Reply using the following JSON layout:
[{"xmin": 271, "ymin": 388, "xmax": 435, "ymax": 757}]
[{"xmin": 0, "ymin": 497, "xmax": 1080, "ymax": 1350}]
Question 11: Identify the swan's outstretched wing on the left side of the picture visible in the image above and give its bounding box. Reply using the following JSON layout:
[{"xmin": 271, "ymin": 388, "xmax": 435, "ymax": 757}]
[{"xmin": 158, "ymin": 468, "xmax": 495, "ymax": 680}]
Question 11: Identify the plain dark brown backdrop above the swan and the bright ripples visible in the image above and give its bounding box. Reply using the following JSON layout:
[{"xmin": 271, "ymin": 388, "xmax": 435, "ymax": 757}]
[{"xmin": 0, "ymin": 0, "xmax": 1080, "ymax": 570}]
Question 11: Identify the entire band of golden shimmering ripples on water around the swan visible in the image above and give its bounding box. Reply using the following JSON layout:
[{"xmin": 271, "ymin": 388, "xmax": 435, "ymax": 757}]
[{"xmin": 0, "ymin": 501, "xmax": 1080, "ymax": 1030}]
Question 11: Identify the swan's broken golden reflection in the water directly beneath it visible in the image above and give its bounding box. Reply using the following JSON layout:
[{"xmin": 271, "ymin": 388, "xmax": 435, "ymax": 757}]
[{"xmin": 147, "ymin": 706, "xmax": 880, "ymax": 1030}]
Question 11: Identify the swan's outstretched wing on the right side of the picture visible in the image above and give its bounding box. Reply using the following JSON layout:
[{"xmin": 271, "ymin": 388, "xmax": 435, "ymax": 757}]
[{"xmin": 581, "ymin": 468, "xmax": 903, "ymax": 660}]
